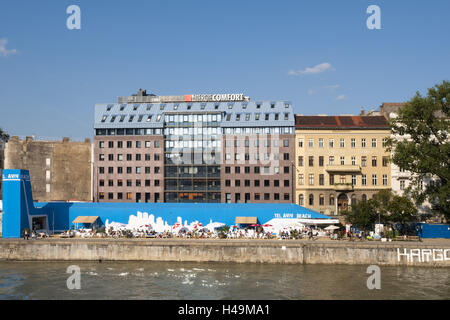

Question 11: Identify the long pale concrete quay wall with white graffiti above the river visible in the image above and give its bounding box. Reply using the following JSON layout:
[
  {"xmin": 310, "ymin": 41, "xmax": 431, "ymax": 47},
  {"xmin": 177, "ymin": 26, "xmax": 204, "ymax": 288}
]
[{"xmin": 0, "ymin": 239, "xmax": 450, "ymax": 267}]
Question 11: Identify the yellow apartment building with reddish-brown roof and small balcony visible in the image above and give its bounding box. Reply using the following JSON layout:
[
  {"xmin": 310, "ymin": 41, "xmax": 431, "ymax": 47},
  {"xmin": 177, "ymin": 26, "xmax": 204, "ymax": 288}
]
[{"xmin": 295, "ymin": 115, "xmax": 391, "ymax": 216}]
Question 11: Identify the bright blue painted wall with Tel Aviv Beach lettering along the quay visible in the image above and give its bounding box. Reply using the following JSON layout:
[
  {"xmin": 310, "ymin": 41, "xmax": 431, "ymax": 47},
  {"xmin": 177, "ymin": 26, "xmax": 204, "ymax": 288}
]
[{"xmin": 3, "ymin": 170, "xmax": 330, "ymax": 238}]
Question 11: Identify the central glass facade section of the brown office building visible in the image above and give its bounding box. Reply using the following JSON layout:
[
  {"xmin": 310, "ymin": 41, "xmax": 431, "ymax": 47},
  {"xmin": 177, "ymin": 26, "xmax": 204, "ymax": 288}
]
[{"xmin": 164, "ymin": 113, "xmax": 222, "ymax": 202}]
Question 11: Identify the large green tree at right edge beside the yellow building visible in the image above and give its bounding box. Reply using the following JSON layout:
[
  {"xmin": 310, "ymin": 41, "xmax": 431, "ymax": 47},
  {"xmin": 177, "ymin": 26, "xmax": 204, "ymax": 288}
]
[{"xmin": 388, "ymin": 81, "xmax": 450, "ymax": 218}]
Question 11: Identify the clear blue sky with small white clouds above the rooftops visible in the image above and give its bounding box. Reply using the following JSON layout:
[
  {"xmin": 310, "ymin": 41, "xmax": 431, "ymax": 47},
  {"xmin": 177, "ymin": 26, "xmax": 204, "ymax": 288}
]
[{"xmin": 0, "ymin": 0, "xmax": 450, "ymax": 138}]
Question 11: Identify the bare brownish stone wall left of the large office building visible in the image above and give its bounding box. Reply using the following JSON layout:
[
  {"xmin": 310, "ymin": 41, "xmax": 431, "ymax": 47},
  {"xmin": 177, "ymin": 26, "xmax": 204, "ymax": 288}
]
[{"xmin": 5, "ymin": 137, "xmax": 92, "ymax": 202}]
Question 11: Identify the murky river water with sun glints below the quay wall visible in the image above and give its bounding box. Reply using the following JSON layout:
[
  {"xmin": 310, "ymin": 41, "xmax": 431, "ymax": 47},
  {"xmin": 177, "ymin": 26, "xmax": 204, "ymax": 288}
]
[{"xmin": 0, "ymin": 262, "xmax": 450, "ymax": 300}]
